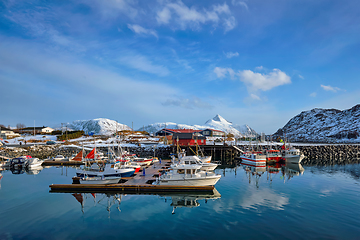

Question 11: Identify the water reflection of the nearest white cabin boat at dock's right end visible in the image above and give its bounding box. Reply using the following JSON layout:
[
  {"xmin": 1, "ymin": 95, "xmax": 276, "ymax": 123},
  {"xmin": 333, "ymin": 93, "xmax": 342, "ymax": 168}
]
[{"xmin": 161, "ymin": 188, "xmax": 221, "ymax": 214}]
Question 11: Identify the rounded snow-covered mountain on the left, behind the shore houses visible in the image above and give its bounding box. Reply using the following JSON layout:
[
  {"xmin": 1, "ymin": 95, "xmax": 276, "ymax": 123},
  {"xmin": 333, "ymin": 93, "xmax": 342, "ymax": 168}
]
[{"xmin": 67, "ymin": 118, "xmax": 131, "ymax": 135}]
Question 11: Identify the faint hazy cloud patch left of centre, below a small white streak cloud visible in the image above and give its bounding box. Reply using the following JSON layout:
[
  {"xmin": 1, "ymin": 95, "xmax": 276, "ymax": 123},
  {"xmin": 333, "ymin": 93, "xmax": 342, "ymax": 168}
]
[{"xmin": 119, "ymin": 54, "xmax": 170, "ymax": 77}]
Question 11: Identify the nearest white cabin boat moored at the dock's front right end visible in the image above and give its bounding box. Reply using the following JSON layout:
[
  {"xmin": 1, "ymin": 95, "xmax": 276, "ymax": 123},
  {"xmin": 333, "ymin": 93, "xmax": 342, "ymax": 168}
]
[{"xmin": 153, "ymin": 164, "xmax": 221, "ymax": 186}]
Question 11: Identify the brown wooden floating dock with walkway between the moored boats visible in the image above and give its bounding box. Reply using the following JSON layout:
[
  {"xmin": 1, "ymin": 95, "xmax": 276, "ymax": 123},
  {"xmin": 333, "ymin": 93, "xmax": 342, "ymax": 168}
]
[{"xmin": 49, "ymin": 160, "xmax": 214, "ymax": 194}]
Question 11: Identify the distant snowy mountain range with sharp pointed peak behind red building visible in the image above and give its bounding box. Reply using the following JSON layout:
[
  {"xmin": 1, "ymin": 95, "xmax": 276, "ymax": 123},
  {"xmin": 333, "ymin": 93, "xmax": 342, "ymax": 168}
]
[{"xmin": 139, "ymin": 115, "xmax": 258, "ymax": 137}]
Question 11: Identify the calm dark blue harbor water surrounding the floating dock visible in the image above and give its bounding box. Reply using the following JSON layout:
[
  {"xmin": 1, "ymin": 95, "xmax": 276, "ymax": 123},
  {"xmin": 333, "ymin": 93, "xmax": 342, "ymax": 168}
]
[{"xmin": 0, "ymin": 164, "xmax": 360, "ymax": 239}]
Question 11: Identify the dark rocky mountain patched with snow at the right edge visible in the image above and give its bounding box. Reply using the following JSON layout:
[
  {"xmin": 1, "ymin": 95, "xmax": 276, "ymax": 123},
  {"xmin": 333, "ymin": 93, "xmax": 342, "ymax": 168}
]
[{"xmin": 274, "ymin": 104, "xmax": 360, "ymax": 142}]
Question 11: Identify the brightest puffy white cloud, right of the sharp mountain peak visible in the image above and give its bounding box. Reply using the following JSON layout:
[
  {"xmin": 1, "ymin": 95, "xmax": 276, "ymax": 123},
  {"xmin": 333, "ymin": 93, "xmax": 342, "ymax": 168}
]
[{"xmin": 238, "ymin": 69, "xmax": 291, "ymax": 92}]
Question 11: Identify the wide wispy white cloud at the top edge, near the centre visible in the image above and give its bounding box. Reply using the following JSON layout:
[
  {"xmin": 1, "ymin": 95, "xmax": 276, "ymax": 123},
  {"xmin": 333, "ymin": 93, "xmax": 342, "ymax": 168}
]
[{"xmin": 156, "ymin": 1, "xmax": 236, "ymax": 32}]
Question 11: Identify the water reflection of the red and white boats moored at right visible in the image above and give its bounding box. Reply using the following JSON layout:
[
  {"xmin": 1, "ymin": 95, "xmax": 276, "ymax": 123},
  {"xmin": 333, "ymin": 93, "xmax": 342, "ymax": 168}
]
[{"xmin": 240, "ymin": 162, "xmax": 305, "ymax": 188}]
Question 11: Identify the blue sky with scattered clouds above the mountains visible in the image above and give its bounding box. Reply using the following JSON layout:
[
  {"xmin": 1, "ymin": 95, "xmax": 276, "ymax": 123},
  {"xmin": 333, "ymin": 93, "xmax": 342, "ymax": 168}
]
[{"xmin": 0, "ymin": 0, "xmax": 360, "ymax": 134}]
